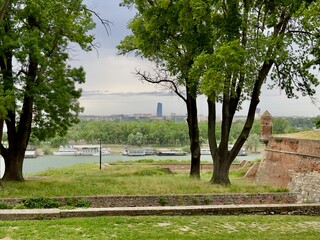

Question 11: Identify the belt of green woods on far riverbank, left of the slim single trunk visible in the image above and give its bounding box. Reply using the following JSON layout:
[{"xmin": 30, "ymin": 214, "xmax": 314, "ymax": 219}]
[{"xmin": 63, "ymin": 121, "xmax": 192, "ymax": 146}]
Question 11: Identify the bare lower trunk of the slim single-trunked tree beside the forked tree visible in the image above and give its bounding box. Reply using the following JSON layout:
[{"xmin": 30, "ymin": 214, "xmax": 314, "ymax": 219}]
[{"xmin": 186, "ymin": 89, "xmax": 200, "ymax": 179}]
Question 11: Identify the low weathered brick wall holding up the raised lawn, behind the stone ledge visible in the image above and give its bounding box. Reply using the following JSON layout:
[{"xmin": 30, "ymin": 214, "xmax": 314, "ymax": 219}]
[{"xmin": 0, "ymin": 192, "xmax": 297, "ymax": 208}]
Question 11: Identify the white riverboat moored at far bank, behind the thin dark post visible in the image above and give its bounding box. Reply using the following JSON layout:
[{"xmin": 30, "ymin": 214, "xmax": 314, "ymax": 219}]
[{"xmin": 53, "ymin": 145, "xmax": 110, "ymax": 156}]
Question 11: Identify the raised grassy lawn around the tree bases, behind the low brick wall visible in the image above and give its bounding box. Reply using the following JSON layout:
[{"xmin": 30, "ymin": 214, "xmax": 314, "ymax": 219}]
[{"xmin": 0, "ymin": 164, "xmax": 283, "ymax": 197}]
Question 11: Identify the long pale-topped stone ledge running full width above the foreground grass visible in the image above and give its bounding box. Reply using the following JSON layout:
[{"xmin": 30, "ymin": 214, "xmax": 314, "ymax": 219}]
[{"xmin": 0, "ymin": 204, "xmax": 320, "ymax": 221}]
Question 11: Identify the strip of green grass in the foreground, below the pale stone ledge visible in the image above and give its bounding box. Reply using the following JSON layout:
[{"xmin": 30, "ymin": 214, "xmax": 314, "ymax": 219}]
[{"xmin": 0, "ymin": 216, "xmax": 320, "ymax": 240}]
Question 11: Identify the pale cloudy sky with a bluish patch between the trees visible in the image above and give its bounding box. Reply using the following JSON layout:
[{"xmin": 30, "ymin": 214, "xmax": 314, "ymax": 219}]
[{"xmin": 71, "ymin": 0, "xmax": 320, "ymax": 117}]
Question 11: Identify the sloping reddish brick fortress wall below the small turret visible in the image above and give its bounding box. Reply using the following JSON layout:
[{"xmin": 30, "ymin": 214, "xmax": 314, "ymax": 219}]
[{"xmin": 256, "ymin": 137, "xmax": 320, "ymax": 201}]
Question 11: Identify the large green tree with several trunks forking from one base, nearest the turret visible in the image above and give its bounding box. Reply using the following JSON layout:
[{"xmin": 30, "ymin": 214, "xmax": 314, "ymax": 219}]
[{"xmin": 193, "ymin": 0, "xmax": 320, "ymax": 185}]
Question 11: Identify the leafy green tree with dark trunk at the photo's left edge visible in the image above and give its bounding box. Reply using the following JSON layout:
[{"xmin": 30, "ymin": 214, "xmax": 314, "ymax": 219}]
[{"xmin": 0, "ymin": 0, "xmax": 95, "ymax": 181}]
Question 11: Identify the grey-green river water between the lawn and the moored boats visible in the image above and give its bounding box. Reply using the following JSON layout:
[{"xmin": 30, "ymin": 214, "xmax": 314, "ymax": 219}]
[{"xmin": 0, "ymin": 154, "xmax": 261, "ymax": 178}]
